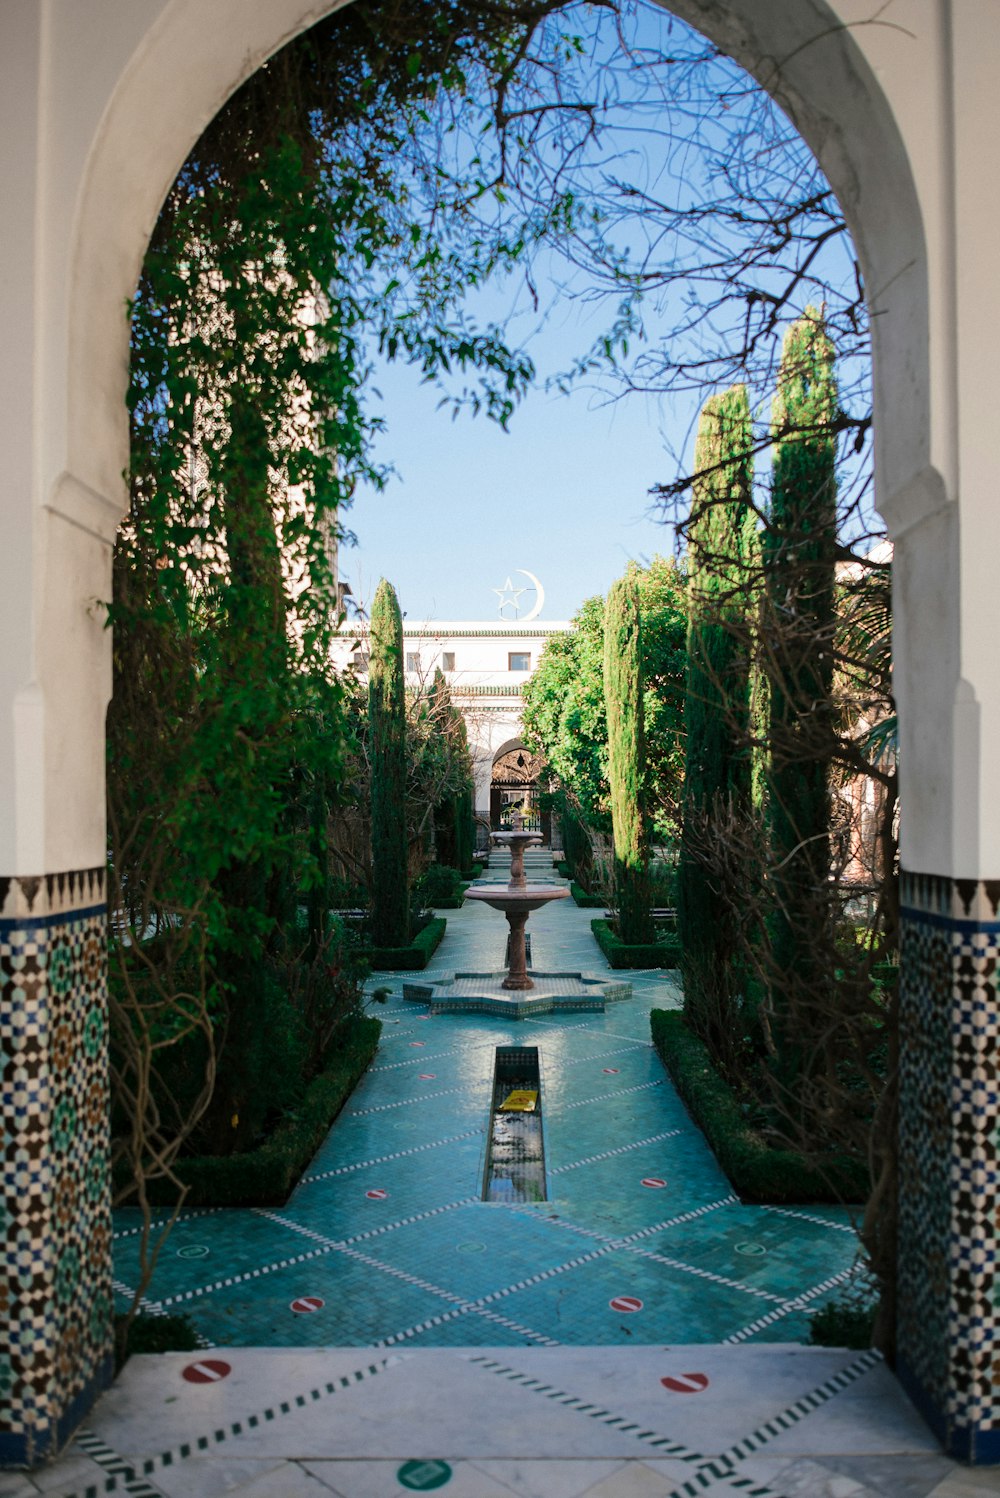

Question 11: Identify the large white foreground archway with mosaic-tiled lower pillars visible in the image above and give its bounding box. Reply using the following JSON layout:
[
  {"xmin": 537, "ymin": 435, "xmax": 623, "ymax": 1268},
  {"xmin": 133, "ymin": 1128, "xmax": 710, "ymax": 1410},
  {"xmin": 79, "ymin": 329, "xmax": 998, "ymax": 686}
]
[{"xmin": 0, "ymin": 0, "xmax": 1000, "ymax": 1465}]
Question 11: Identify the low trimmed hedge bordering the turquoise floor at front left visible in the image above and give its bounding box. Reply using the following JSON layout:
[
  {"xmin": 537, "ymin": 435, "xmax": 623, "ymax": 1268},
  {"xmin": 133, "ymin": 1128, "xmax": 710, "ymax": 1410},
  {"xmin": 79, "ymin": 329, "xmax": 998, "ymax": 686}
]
[{"xmin": 150, "ymin": 1016, "xmax": 382, "ymax": 1210}]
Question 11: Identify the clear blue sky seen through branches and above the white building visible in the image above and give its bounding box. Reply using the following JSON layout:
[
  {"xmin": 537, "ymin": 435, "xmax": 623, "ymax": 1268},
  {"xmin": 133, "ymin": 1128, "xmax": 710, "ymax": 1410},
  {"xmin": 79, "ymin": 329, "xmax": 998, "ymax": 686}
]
[{"xmin": 333, "ymin": 6, "xmax": 853, "ymax": 622}]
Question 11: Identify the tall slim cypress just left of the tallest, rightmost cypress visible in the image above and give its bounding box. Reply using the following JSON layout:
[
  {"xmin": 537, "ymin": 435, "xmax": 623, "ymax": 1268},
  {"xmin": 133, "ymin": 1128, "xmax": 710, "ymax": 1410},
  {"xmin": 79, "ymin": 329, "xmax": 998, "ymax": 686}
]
[{"xmin": 678, "ymin": 385, "xmax": 757, "ymax": 1062}]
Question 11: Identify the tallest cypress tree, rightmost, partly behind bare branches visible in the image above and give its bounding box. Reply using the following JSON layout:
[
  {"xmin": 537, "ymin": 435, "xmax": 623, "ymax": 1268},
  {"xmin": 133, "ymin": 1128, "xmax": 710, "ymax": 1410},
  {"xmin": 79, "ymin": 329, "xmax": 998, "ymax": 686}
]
[{"xmin": 765, "ymin": 307, "xmax": 837, "ymax": 1092}]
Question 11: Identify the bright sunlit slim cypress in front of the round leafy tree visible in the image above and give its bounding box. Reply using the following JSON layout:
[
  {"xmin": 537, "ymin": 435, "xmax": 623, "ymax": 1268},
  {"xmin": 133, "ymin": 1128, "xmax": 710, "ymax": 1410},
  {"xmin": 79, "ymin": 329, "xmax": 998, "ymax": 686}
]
[{"xmin": 605, "ymin": 571, "xmax": 654, "ymax": 944}]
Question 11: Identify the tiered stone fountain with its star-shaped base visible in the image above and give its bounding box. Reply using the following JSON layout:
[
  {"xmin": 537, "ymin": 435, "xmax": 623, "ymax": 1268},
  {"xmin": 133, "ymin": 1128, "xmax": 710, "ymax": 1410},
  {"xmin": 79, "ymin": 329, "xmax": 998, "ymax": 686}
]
[{"xmin": 403, "ymin": 813, "xmax": 632, "ymax": 1020}]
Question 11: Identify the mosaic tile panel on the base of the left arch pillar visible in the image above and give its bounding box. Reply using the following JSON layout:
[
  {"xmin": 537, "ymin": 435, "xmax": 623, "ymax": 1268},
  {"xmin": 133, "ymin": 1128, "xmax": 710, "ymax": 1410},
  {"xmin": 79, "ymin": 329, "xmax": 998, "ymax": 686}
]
[{"xmin": 0, "ymin": 869, "xmax": 112, "ymax": 1465}]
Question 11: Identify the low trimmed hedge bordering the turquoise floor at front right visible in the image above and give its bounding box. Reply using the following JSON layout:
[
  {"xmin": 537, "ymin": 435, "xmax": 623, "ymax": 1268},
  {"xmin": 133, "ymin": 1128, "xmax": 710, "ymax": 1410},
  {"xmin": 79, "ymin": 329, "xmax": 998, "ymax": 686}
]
[{"xmin": 650, "ymin": 1010, "xmax": 870, "ymax": 1203}]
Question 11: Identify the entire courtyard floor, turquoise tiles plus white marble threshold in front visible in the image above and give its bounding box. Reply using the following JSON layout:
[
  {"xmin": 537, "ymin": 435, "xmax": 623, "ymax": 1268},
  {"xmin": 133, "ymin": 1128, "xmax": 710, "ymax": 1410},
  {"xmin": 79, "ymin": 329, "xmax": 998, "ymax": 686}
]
[{"xmin": 9, "ymin": 862, "xmax": 1000, "ymax": 1498}]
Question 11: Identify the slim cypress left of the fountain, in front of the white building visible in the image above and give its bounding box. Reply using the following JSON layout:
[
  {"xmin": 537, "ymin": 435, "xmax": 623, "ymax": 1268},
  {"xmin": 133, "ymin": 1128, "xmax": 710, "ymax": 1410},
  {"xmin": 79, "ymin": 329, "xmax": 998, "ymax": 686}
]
[{"xmin": 368, "ymin": 578, "xmax": 410, "ymax": 947}]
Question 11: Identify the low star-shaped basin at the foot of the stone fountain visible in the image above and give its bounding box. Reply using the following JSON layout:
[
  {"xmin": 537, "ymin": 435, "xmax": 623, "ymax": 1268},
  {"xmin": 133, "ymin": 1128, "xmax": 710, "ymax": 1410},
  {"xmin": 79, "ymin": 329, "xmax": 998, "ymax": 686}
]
[{"xmin": 403, "ymin": 969, "xmax": 632, "ymax": 1020}]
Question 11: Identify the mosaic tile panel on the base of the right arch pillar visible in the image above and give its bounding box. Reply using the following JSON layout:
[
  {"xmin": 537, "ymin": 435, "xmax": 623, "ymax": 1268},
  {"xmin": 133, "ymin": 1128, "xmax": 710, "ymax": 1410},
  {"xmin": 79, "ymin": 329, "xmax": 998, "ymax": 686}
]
[{"xmin": 898, "ymin": 873, "xmax": 1000, "ymax": 1459}]
